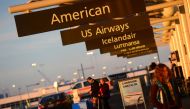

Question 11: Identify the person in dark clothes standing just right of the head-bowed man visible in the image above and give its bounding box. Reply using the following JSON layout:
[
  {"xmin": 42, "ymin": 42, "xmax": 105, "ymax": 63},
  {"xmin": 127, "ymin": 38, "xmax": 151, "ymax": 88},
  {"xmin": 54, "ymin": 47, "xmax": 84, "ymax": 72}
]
[{"xmin": 99, "ymin": 79, "xmax": 110, "ymax": 109}]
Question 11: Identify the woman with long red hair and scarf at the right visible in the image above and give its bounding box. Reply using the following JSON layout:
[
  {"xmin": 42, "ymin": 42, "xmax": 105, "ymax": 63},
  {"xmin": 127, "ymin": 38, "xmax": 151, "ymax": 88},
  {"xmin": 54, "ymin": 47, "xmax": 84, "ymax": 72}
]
[{"xmin": 150, "ymin": 64, "xmax": 182, "ymax": 109}]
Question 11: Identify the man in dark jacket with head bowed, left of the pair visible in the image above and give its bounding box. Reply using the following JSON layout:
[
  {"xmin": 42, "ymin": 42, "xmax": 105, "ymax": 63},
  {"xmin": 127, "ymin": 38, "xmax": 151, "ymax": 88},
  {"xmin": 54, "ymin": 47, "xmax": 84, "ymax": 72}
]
[{"xmin": 87, "ymin": 77, "xmax": 100, "ymax": 109}]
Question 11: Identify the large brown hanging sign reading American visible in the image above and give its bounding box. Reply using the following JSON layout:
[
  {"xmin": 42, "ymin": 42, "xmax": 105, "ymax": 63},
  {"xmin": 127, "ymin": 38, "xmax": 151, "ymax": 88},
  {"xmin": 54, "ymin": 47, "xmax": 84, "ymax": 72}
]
[{"xmin": 14, "ymin": 0, "xmax": 146, "ymax": 37}]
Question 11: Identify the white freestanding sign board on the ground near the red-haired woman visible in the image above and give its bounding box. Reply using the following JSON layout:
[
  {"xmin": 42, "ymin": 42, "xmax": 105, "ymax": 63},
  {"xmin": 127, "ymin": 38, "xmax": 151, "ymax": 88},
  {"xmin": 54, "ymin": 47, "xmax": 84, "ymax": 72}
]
[{"xmin": 118, "ymin": 78, "xmax": 146, "ymax": 109}]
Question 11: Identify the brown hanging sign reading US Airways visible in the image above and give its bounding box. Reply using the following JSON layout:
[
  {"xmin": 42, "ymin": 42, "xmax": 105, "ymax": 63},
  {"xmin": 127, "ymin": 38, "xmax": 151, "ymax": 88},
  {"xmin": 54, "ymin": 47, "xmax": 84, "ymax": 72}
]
[{"xmin": 61, "ymin": 14, "xmax": 150, "ymax": 45}]
